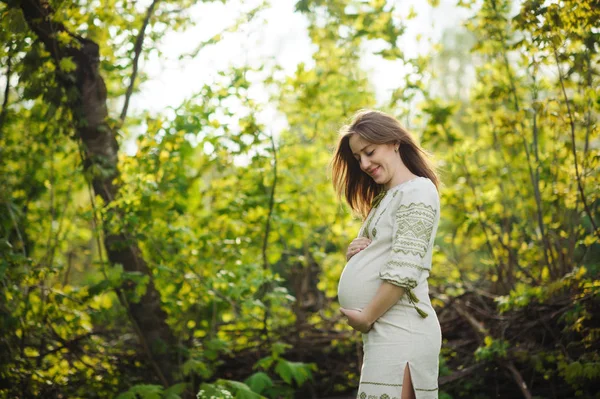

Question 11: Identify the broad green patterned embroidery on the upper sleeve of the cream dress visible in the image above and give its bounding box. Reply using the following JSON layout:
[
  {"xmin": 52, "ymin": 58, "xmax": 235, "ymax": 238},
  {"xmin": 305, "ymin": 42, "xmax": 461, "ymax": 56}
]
[{"xmin": 392, "ymin": 202, "xmax": 437, "ymax": 258}]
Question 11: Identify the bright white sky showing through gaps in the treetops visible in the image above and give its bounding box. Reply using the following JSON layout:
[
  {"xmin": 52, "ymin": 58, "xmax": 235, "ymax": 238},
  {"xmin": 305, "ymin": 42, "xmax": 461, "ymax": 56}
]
[{"xmin": 126, "ymin": 0, "xmax": 467, "ymax": 153}]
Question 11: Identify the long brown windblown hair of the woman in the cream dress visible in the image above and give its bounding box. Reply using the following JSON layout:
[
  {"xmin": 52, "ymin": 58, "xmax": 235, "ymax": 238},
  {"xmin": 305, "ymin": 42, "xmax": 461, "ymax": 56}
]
[{"xmin": 331, "ymin": 110, "xmax": 440, "ymax": 218}]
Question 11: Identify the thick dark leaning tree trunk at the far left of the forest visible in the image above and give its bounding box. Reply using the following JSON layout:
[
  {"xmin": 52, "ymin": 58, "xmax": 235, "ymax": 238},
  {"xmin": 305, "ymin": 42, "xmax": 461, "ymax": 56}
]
[{"xmin": 20, "ymin": 0, "xmax": 177, "ymax": 385}]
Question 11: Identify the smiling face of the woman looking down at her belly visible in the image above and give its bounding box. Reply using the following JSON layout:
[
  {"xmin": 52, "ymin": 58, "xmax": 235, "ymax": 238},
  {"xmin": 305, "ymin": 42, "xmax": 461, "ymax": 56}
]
[{"xmin": 349, "ymin": 134, "xmax": 402, "ymax": 188}]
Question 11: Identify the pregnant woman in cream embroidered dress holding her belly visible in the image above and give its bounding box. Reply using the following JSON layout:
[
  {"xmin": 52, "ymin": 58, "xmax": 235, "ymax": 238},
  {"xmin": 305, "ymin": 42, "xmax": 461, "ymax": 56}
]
[{"xmin": 332, "ymin": 111, "xmax": 441, "ymax": 399}]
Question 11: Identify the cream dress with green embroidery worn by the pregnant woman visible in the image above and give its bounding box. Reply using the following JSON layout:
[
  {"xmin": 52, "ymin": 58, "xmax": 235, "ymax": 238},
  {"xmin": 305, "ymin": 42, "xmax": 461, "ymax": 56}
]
[{"xmin": 338, "ymin": 177, "xmax": 442, "ymax": 399}]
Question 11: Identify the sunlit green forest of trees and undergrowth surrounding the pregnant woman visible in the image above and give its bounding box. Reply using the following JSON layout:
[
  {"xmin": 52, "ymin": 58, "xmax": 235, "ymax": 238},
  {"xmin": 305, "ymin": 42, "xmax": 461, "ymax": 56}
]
[{"xmin": 0, "ymin": 0, "xmax": 600, "ymax": 399}]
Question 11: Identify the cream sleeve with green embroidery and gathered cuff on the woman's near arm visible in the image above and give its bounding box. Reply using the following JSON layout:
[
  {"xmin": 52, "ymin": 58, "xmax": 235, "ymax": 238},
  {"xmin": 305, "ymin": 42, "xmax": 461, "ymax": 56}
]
[{"xmin": 379, "ymin": 181, "xmax": 439, "ymax": 291}]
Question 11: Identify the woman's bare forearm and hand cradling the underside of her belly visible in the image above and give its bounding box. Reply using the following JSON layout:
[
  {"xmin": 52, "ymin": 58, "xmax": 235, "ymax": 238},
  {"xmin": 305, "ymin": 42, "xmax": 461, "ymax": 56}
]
[{"xmin": 340, "ymin": 280, "xmax": 405, "ymax": 333}]
